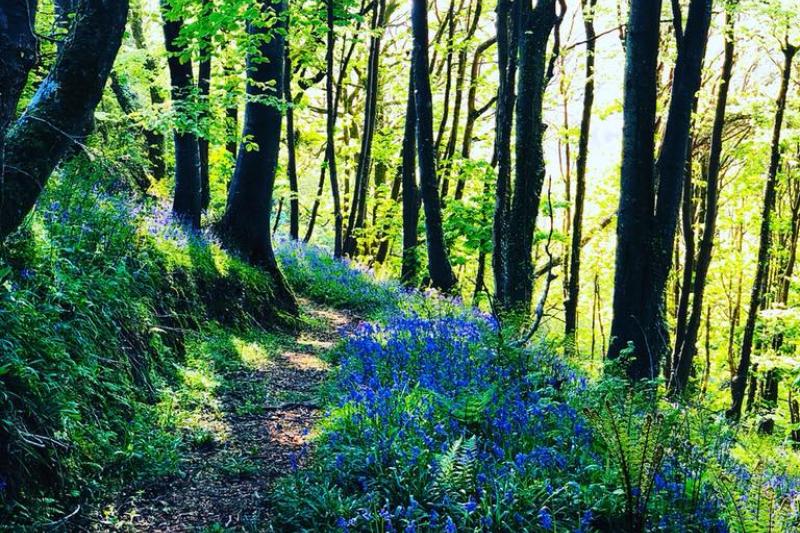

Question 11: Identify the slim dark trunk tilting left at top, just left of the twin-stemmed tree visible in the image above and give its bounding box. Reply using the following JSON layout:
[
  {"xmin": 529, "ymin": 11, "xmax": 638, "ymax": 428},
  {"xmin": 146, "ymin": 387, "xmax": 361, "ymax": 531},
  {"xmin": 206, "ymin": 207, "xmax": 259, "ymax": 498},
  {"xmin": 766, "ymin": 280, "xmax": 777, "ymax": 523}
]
[{"xmin": 411, "ymin": 0, "xmax": 456, "ymax": 292}]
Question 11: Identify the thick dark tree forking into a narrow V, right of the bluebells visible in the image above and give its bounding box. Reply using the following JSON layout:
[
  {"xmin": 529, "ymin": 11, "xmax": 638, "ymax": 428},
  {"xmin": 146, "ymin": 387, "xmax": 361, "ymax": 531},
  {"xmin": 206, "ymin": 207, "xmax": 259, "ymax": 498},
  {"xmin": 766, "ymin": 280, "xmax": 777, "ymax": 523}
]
[{"xmin": 608, "ymin": 0, "xmax": 711, "ymax": 379}]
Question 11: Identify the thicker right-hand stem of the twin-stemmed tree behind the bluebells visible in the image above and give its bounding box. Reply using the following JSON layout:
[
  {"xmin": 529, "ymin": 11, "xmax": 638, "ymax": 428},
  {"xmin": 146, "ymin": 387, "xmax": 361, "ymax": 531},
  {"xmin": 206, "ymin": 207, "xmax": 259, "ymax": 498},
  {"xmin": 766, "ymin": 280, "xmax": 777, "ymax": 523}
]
[{"xmin": 504, "ymin": 0, "xmax": 556, "ymax": 313}]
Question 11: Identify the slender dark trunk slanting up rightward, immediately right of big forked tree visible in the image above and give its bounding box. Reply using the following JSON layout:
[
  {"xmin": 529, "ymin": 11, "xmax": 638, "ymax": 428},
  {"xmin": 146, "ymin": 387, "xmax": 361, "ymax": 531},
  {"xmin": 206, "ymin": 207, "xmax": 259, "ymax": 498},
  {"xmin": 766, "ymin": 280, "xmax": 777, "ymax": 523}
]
[{"xmin": 673, "ymin": 6, "xmax": 735, "ymax": 392}]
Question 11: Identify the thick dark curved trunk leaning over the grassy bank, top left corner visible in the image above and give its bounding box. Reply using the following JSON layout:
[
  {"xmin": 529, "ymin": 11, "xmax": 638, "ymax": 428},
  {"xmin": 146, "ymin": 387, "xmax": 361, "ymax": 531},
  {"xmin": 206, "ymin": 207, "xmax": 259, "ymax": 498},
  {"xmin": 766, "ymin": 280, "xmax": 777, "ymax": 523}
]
[{"xmin": 0, "ymin": 0, "xmax": 128, "ymax": 240}]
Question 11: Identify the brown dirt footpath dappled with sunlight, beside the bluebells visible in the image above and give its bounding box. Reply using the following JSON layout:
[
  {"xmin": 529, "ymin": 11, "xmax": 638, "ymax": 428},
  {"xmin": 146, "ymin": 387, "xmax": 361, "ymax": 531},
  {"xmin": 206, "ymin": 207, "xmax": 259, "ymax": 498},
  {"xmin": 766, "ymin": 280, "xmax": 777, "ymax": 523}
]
[{"xmin": 92, "ymin": 300, "xmax": 357, "ymax": 532}]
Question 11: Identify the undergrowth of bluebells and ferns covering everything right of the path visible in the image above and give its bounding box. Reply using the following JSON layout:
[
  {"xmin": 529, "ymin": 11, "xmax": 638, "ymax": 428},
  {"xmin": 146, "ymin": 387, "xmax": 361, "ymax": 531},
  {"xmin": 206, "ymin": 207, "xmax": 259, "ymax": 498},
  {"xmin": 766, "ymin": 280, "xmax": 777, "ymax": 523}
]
[{"xmin": 272, "ymin": 250, "xmax": 800, "ymax": 533}]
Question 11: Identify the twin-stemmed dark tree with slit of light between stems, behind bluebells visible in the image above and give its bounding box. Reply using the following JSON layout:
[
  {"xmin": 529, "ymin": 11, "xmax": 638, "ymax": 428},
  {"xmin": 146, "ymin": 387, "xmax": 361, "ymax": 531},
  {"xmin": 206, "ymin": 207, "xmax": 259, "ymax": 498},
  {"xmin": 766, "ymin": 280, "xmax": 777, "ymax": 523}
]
[{"xmin": 493, "ymin": 0, "xmax": 556, "ymax": 313}]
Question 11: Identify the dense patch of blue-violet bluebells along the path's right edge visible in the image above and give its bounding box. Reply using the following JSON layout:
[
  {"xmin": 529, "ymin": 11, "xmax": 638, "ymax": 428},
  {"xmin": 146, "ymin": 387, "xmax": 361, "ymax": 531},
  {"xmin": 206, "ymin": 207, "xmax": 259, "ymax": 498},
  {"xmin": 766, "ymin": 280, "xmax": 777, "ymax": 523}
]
[{"xmin": 292, "ymin": 306, "xmax": 608, "ymax": 531}]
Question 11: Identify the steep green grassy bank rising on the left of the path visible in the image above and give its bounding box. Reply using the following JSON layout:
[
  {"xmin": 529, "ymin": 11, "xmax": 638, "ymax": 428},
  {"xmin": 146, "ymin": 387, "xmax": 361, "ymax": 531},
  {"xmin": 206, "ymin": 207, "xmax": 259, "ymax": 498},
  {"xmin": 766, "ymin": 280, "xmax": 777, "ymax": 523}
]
[{"xmin": 0, "ymin": 157, "xmax": 289, "ymax": 527}]
